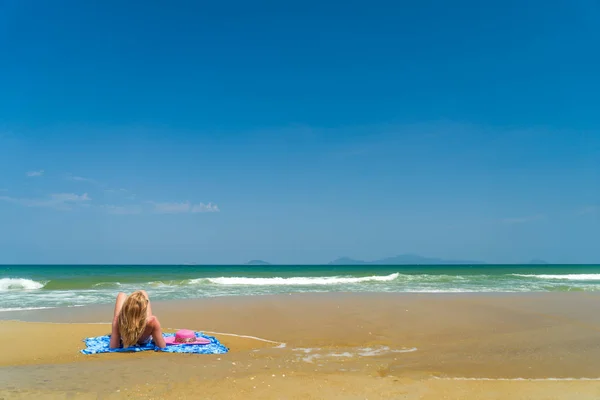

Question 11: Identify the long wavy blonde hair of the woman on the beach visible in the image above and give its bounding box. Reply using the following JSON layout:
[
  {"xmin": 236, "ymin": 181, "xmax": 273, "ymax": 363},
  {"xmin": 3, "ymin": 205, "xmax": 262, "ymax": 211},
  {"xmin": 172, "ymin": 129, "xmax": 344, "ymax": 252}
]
[{"xmin": 119, "ymin": 290, "xmax": 148, "ymax": 347}]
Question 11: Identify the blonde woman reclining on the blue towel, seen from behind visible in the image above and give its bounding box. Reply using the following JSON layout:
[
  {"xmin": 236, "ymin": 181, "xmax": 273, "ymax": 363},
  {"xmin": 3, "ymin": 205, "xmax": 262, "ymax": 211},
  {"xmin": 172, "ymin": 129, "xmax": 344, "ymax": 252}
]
[{"xmin": 110, "ymin": 290, "xmax": 167, "ymax": 349}]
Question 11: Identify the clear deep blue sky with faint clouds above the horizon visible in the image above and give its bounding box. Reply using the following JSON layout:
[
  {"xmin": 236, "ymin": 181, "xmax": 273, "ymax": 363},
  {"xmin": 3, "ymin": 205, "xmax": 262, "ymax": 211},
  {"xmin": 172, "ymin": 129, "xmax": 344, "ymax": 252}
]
[{"xmin": 0, "ymin": 0, "xmax": 600, "ymax": 263}]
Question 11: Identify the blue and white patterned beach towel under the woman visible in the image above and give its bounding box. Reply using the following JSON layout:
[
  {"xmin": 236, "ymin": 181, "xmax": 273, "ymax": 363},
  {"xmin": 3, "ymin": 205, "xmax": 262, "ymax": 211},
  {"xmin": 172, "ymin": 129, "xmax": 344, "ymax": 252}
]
[{"xmin": 81, "ymin": 332, "xmax": 229, "ymax": 354}]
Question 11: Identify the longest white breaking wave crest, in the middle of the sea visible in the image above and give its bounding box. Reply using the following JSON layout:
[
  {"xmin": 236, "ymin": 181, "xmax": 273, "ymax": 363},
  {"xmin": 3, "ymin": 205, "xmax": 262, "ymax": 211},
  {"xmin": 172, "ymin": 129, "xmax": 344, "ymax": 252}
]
[{"xmin": 197, "ymin": 273, "xmax": 400, "ymax": 286}]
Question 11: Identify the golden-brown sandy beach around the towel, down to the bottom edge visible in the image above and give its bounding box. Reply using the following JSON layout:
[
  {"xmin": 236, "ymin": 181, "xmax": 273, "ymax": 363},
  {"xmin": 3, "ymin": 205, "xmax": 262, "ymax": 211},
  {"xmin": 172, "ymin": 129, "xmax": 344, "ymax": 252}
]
[{"xmin": 0, "ymin": 293, "xmax": 600, "ymax": 399}]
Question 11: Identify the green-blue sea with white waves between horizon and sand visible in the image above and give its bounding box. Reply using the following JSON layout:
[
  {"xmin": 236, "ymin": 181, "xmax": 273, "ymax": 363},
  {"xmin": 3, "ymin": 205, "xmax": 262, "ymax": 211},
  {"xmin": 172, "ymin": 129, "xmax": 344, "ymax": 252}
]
[{"xmin": 0, "ymin": 265, "xmax": 600, "ymax": 312}]
